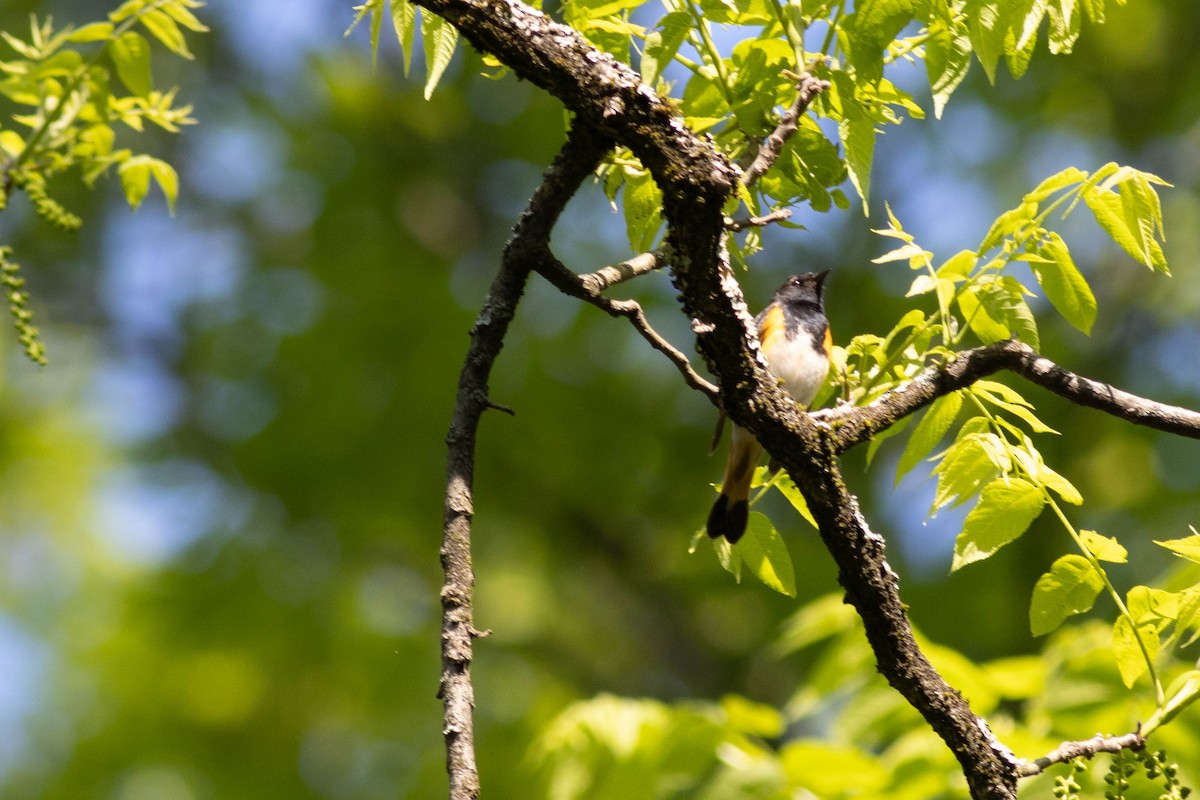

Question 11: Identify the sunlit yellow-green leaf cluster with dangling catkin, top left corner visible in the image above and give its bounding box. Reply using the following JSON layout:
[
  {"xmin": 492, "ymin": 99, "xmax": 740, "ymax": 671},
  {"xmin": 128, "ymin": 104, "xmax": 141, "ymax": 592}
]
[{"xmin": 0, "ymin": 0, "xmax": 208, "ymax": 362}]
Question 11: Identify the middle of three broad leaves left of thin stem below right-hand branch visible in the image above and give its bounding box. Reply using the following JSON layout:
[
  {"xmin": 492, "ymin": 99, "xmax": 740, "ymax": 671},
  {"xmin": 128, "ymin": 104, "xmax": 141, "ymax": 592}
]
[{"xmin": 950, "ymin": 477, "xmax": 1045, "ymax": 571}]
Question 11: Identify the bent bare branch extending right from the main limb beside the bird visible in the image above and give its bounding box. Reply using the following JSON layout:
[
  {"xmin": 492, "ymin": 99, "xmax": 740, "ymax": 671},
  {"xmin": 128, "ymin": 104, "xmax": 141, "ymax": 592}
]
[{"xmin": 818, "ymin": 339, "xmax": 1200, "ymax": 452}]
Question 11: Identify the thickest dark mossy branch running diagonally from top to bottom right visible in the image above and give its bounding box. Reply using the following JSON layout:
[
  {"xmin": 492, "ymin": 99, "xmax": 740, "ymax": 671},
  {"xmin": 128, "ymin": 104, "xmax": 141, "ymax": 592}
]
[{"xmin": 416, "ymin": 0, "xmax": 1016, "ymax": 800}]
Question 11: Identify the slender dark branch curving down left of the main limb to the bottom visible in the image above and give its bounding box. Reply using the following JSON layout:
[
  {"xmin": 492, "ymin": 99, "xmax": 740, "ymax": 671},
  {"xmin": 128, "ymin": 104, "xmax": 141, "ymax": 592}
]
[{"xmin": 438, "ymin": 118, "xmax": 610, "ymax": 800}]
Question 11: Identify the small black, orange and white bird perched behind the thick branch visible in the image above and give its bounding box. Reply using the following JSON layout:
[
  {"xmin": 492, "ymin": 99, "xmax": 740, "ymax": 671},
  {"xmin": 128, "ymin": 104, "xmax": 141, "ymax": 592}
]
[{"xmin": 708, "ymin": 271, "xmax": 833, "ymax": 545}]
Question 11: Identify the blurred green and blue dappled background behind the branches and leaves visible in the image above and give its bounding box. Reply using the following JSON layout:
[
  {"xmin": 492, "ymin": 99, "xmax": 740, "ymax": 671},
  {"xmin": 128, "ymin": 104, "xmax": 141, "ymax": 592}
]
[{"xmin": 0, "ymin": 0, "xmax": 1200, "ymax": 800}]
